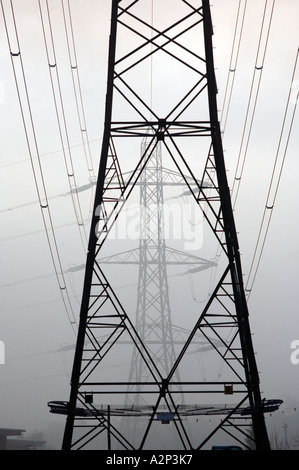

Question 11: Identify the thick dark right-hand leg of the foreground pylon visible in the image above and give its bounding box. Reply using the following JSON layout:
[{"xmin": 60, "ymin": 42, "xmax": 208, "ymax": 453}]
[{"xmin": 202, "ymin": 0, "xmax": 270, "ymax": 450}]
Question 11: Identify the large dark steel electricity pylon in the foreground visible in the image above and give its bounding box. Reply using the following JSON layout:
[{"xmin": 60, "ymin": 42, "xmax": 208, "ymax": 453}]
[{"xmin": 50, "ymin": 0, "xmax": 279, "ymax": 450}]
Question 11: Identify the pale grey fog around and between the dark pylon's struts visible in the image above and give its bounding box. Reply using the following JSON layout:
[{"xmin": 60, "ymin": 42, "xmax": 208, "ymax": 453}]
[{"xmin": 0, "ymin": 0, "xmax": 299, "ymax": 449}]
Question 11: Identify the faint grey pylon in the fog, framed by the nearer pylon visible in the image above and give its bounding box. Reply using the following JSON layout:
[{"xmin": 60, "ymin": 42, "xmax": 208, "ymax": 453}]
[{"xmin": 100, "ymin": 136, "xmax": 215, "ymax": 443}]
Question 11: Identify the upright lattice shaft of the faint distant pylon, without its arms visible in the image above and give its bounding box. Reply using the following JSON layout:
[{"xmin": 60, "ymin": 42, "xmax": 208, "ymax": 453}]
[{"xmin": 122, "ymin": 138, "xmax": 182, "ymax": 443}]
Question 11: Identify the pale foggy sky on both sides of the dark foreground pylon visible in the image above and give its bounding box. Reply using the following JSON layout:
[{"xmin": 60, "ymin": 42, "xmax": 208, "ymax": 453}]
[{"xmin": 0, "ymin": 0, "xmax": 299, "ymax": 448}]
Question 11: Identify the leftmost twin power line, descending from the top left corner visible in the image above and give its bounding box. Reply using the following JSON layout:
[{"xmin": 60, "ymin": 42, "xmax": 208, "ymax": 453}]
[{"xmin": 1, "ymin": 0, "xmax": 76, "ymax": 332}]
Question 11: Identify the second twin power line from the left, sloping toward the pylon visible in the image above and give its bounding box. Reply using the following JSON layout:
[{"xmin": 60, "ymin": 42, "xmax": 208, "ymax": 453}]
[{"xmin": 39, "ymin": 0, "xmax": 87, "ymax": 251}]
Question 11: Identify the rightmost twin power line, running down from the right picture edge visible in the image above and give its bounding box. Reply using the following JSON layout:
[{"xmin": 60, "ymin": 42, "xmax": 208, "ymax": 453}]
[{"xmin": 246, "ymin": 49, "xmax": 299, "ymax": 296}]
